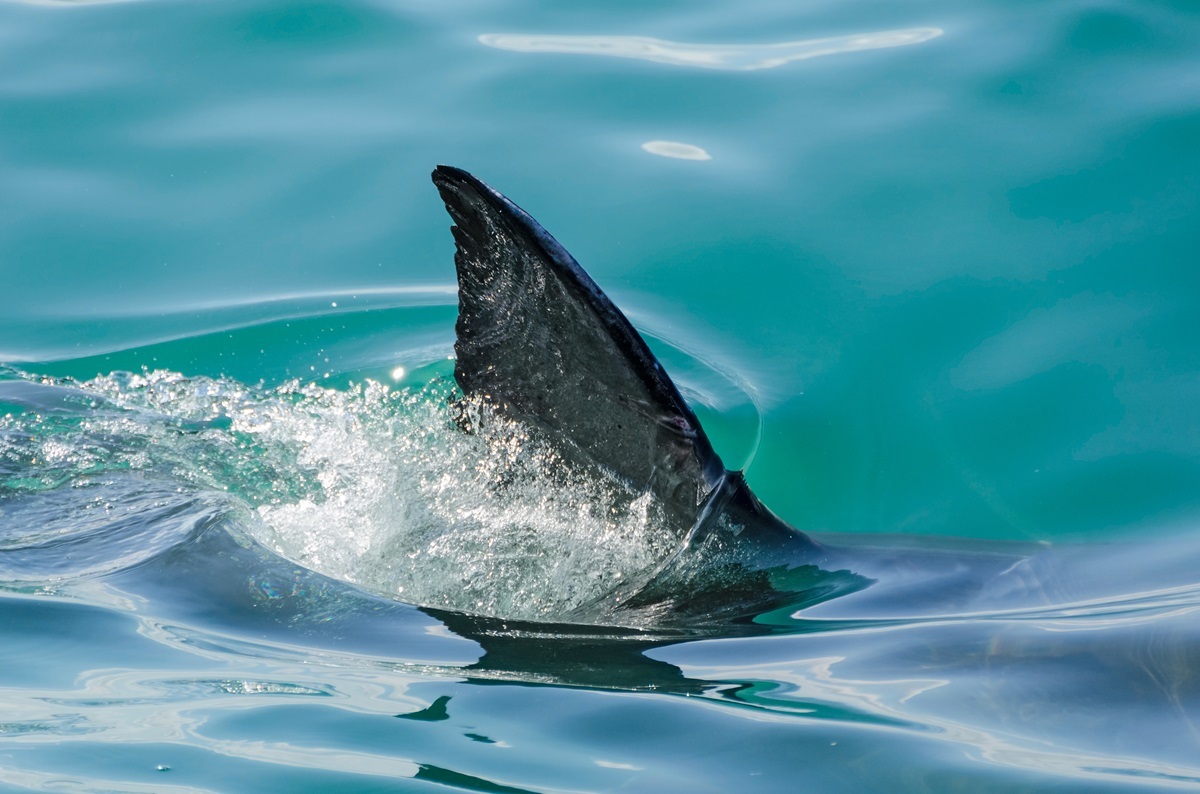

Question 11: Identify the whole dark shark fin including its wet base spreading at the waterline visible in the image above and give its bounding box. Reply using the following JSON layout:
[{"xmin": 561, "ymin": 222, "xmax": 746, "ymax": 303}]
[{"xmin": 433, "ymin": 166, "xmax": 866, "ymax": 619}]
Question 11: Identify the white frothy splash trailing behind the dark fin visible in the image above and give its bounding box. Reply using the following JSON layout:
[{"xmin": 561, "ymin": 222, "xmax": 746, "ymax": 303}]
[{"xmin": 0, "ymin": 371, "xmax": 680, "ymax": 620}]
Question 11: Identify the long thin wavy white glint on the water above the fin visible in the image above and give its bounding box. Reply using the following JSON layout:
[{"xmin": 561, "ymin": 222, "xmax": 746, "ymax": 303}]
[{"xmin": 479, "ymin": 28, "xmax": 943, "ymax": 72}]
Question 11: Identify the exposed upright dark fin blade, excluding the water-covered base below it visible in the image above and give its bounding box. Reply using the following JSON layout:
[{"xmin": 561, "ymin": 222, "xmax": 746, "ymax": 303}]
[{"xmin": 433, "ymin": 166, "xmax": 726, "ymax": 536}]
